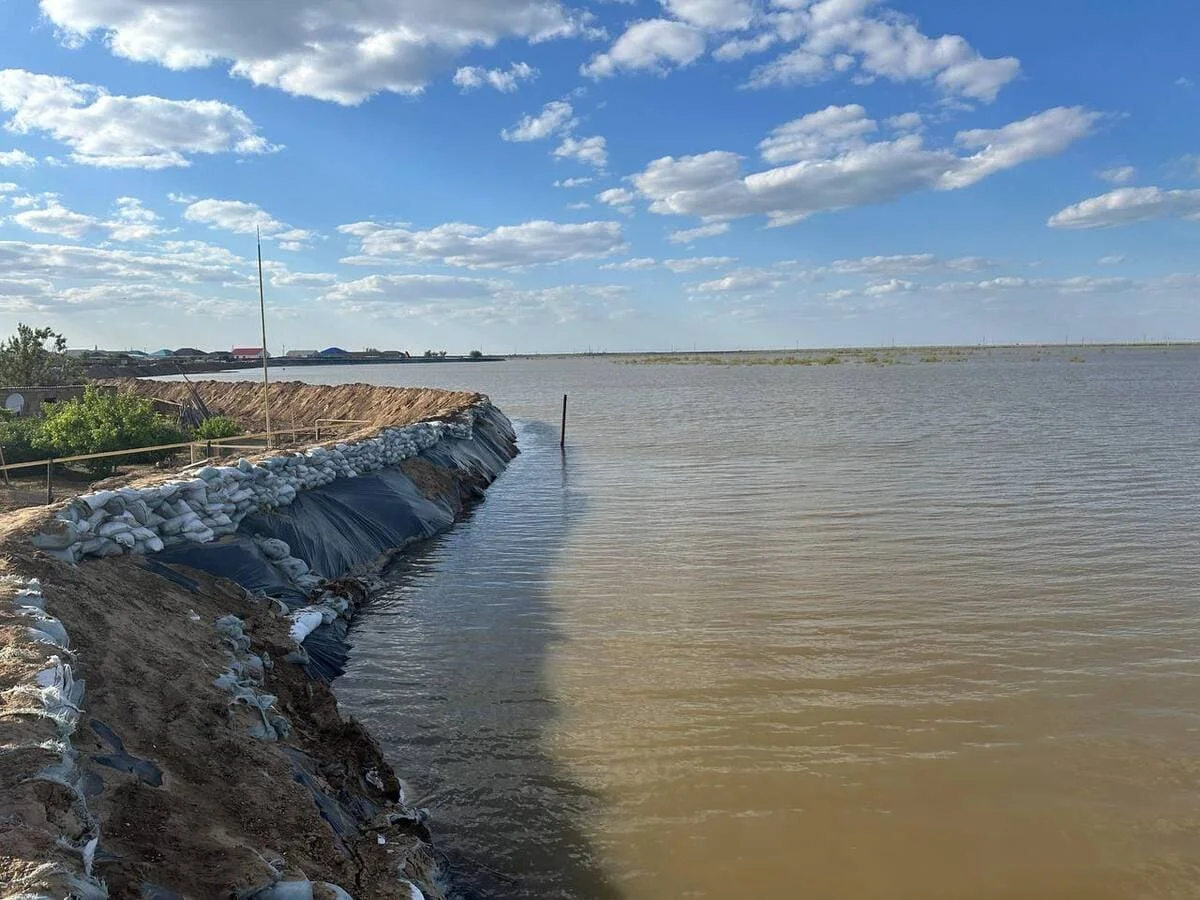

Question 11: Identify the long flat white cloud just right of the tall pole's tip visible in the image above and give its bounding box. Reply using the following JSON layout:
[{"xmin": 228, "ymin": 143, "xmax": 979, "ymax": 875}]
[{"xmin": 337, "ymin": 221, "xmax": 625, "ymax": 269}]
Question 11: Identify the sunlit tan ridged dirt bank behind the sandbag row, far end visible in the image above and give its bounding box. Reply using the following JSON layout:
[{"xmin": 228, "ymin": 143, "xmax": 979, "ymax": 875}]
[{"xmin": 107, "ymin": 378, "xmax": 481, "ymax": 433}]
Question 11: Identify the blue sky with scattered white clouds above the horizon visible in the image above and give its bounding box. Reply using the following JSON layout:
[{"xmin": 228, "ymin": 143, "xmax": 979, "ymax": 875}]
[{"xmin": 0, "ymin": 0, "xmax": 1200, "ymax": 354}]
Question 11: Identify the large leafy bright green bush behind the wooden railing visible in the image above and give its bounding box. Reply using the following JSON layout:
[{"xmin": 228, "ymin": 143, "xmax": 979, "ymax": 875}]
[{"xmin": 35, "ymin": 386, "xmax": 187, "ymax": 476}]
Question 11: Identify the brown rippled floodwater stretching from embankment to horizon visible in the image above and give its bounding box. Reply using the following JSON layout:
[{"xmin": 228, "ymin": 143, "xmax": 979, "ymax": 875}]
[{"xmin": 218, "ymin": 348, "xmax": 1200, "ymax": 900}]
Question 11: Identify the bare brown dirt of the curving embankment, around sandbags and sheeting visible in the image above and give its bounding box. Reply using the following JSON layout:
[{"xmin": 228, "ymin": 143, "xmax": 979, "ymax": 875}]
[{"xmin": 0, "ymin": 383, "xmax": 515, "ymax": 900}]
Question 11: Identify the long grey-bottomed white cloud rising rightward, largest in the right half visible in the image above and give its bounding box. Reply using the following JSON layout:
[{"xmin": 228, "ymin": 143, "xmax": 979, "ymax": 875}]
[{"xmin": 631, "ymin": 107, "xmax": 1098, "ymax": 226}]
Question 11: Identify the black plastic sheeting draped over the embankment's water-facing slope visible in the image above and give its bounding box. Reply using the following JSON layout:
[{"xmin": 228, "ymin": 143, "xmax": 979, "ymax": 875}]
[{"xmin": 146, "ymin": 412, "xmax": 511, "ymax": 682}]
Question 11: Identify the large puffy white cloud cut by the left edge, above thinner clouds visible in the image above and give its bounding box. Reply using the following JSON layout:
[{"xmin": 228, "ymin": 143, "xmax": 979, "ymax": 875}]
[{"xmin": 0, "ymin": 68, "xmax": 278, "ymax": 169}]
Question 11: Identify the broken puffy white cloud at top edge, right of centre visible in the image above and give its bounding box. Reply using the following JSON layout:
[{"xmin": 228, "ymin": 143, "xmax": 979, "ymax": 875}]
[{"xmin": 750, "ymin": 0, "xmax": 1020, "ymax": 102}]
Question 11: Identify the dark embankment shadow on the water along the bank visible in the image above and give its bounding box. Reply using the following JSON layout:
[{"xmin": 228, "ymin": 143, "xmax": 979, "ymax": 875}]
[{"xmin": 337, "ymin": 424, "xmax": 620, "ymax": 900}]
